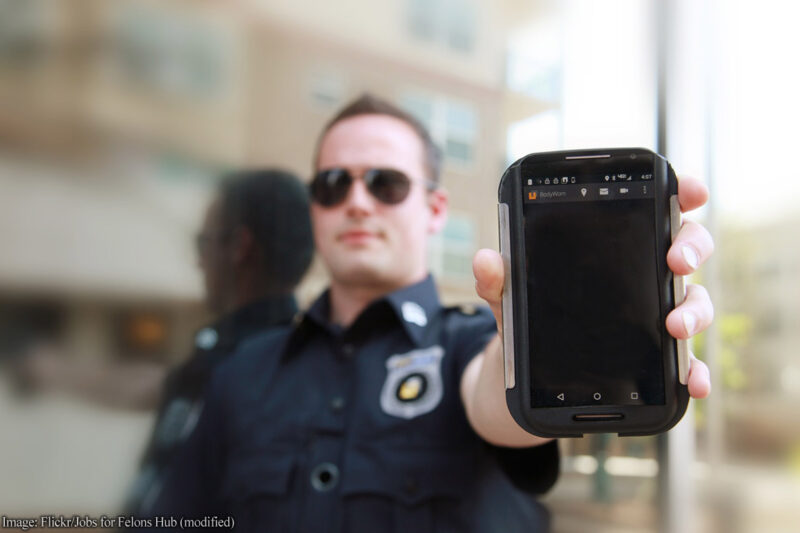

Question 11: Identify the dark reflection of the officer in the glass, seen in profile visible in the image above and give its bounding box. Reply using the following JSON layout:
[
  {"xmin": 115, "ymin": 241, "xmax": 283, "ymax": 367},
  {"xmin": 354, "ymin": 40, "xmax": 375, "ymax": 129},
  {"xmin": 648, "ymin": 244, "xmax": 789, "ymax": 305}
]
[{"xmin": 127, "ymin": 170, "xmax": 313, "ymax": 515}]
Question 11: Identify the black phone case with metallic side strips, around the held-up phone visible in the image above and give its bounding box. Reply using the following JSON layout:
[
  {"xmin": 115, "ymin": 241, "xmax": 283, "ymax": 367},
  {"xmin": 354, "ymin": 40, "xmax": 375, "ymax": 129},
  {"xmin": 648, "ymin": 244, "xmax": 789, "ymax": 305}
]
[{"xmin": 498, "ymin": 148, "xmax": 689, "ymax": 437}]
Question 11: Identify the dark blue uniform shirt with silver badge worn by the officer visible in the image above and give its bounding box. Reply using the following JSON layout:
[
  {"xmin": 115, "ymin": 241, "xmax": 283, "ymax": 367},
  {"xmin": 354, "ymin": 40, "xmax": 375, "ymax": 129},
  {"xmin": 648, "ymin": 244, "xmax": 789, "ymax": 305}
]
[{"xmin": 155, "ymin": 277, "xmax": 558, "ymax": 533}]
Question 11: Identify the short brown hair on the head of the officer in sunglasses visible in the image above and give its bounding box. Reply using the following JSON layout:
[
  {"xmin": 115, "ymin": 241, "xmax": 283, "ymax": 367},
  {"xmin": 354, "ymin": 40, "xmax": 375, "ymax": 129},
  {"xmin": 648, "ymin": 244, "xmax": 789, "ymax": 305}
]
[{"xmin": 314, "ymin": 93, "xmax": 442, "ymax": 184}]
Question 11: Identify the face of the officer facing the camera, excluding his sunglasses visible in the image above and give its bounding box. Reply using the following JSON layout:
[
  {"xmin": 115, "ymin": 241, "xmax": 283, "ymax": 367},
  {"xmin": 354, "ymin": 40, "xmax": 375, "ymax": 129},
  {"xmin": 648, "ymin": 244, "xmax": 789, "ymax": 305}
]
[{"xmin": 311, "ymin": 115, "xmax": 447, "ymax": 287}]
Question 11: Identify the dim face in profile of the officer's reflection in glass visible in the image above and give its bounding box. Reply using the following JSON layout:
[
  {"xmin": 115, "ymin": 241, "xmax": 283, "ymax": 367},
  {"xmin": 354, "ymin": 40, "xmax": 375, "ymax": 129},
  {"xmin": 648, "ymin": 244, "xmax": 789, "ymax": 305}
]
[{"xmin": 197, "ymin": 198, "xmax": 233, "ymax": 314}]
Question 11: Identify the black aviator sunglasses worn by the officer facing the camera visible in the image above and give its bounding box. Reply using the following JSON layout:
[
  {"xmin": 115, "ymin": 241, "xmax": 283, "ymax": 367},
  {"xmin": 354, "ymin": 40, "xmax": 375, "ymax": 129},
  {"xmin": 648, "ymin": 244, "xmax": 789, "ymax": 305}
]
[{"xmin": 310, "ymin": 168, "xmax": 436, "ymax": 207}]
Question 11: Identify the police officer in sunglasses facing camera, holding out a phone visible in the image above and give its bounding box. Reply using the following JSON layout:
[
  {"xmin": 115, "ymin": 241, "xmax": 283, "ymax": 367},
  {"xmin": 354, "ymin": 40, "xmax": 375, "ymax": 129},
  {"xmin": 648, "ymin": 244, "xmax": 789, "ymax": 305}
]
[{"xmin": 148, "ymin": 96, "xmax": 711, "ymax": 533}]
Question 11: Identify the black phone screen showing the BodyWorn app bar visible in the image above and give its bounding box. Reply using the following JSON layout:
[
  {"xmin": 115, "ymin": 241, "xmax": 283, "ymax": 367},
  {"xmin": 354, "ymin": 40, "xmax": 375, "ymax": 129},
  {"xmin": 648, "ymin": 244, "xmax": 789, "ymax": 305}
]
[{"xmin": 522, "ymin": 155, "xmax": 665, "ymax": 407}]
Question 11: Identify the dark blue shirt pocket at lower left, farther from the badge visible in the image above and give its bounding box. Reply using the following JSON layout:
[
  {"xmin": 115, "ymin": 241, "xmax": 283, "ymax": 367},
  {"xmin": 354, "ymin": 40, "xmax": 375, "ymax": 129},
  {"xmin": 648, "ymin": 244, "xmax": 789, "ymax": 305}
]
[{"xmin": 220, "ymin": 449, "xmax": 297, "ymax": 531}]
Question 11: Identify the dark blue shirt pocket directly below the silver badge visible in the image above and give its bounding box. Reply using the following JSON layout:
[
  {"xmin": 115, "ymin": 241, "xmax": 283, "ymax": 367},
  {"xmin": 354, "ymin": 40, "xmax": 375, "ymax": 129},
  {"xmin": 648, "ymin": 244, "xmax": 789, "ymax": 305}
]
[{"xmin": 341, "ymin": 446, "xmax": 474, "ymax": 533}]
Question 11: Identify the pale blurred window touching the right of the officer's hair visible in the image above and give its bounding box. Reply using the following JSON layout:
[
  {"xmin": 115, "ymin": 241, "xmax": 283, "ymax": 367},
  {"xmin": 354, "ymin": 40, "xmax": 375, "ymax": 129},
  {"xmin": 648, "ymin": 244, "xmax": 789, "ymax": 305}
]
[{"xmin": 400, "ymin": 92, "xmax": 478, "ymax": 168}]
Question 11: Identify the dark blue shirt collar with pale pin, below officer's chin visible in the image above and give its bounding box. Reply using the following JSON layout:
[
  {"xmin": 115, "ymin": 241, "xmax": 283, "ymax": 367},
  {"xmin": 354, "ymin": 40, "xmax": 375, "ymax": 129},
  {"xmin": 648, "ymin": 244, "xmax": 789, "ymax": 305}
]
[{"xmin": 292, "ymin": 275, "xmax": 441, "ymax": 346}]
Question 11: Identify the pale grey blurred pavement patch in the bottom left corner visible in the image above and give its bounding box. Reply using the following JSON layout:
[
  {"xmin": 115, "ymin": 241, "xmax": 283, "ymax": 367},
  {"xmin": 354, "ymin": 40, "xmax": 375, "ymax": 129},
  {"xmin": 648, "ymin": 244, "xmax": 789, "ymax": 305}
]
[{"xmin": 0, "ymin": 374, "xmax": 152, "ymax": 516}]
